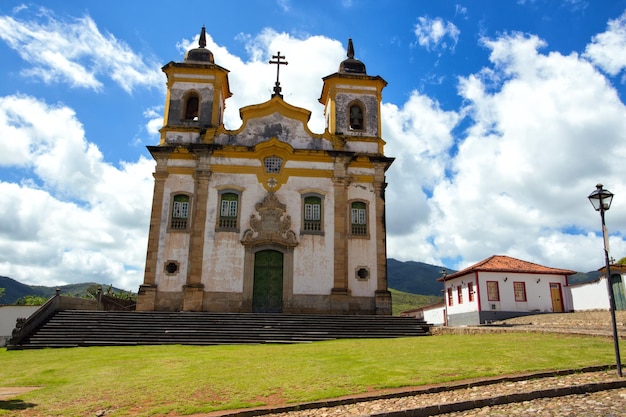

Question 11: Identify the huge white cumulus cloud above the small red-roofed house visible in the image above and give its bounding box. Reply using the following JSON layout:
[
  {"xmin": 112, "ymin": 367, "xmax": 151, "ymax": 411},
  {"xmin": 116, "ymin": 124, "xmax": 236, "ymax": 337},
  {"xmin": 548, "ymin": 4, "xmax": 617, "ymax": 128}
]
[{"xmin": 400, "ymin": 34, "xmax": 626, "ymax": 271}]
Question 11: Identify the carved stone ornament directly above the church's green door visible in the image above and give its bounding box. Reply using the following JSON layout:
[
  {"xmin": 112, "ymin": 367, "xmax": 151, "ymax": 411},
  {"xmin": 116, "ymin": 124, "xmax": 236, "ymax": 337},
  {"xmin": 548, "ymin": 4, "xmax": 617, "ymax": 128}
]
[{"xmin": 241, "ymin": 192, "xmax": 298, "ymax": 247}]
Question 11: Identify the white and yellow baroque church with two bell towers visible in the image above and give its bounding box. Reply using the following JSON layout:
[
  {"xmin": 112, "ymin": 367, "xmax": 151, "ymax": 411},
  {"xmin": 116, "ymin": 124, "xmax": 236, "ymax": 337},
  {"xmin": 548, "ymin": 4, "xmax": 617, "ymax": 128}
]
[{"xmin": 137, "ymin": 27, "xmax": 393, "ymax": 315}]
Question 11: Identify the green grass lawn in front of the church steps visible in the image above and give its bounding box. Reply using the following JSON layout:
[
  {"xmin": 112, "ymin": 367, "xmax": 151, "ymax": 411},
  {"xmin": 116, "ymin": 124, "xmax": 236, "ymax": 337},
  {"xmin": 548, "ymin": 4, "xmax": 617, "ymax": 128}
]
[{"xmin": 0, "ymin": 333, "xmax": 614, "ymax": 416}]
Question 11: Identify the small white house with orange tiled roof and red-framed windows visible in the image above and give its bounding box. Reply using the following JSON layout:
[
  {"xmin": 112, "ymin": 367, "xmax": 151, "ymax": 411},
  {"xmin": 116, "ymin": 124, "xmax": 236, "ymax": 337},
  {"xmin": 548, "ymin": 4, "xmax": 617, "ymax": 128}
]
[{"xmin": 438, "ymin": 255, "xmax": 576, "ymax": 326}]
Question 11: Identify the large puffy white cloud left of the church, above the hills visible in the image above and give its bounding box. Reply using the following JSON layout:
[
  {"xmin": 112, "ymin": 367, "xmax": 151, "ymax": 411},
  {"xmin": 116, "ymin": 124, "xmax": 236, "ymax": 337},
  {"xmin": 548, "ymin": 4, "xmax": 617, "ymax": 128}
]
[{"xmin": 0, "ymin": 96, "xmax": 154, "ymax": 290}]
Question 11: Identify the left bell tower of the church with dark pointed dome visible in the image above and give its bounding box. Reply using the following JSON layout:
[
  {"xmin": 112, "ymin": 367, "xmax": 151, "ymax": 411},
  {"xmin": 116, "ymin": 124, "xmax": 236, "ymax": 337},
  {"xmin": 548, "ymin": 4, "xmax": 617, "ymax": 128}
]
[{"xmin": 160, "ymin": 26, "xmax": 232, "ymax": 145}]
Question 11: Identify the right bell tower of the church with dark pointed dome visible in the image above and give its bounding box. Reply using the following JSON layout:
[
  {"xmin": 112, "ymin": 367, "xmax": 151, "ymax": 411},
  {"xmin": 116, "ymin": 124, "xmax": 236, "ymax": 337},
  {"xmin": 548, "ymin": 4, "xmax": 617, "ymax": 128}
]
[{"xmin": 319, "ymin": 39, "xmax": 387, "ymax": 140}]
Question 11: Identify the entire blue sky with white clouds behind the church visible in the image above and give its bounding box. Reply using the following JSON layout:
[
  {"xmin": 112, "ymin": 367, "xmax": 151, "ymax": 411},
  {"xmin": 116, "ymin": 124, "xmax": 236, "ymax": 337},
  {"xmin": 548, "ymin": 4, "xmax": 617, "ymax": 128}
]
[{"xmin": 0, "ymin": 0, "xmax": 626, "ymax": 290}]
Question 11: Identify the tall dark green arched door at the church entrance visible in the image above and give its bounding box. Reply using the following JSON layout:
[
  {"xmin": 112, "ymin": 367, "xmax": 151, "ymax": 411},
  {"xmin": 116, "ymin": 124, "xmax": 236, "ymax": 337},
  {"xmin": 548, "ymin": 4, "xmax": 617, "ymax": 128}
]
[{"xmin": 252, "ymin": 250, "xmax": 283, "ymax": 313}]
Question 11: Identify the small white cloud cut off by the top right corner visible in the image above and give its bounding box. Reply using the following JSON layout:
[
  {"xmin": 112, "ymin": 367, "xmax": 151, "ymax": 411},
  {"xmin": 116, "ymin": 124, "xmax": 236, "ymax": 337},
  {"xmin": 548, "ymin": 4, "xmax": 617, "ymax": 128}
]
[{"xmin": 584, "ymin": 12, "xmax": 626, "ymax": 75}]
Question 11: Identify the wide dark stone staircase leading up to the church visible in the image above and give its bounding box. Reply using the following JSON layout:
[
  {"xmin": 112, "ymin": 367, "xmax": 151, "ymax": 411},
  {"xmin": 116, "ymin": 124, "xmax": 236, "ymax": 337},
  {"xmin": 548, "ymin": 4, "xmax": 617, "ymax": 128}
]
[{"xmin": 7, "ymin": 310, "xmax": 429, "ymax": 349}]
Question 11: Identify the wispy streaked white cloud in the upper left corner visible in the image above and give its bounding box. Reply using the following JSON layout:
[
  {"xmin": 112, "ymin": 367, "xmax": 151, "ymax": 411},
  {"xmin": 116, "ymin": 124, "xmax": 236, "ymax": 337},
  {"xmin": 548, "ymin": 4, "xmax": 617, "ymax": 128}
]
[{"xmin": 0, "ymin": 8, "xmax": 162, "ymax": 93}]
